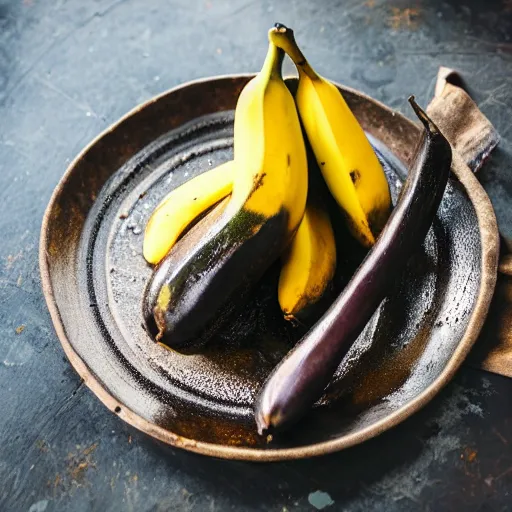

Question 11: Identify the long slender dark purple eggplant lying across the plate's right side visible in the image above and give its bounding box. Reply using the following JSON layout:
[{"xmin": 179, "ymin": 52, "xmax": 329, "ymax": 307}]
[{"xmin": 255, "ymin": 97, "xmax": 451, "ymax": 433}]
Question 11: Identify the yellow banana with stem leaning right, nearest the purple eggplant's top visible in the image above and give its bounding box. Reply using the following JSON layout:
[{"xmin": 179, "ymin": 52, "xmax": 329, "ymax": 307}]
[{"xmin": 270, "ymin": 24, "xmax": 391, "ymax": 247}]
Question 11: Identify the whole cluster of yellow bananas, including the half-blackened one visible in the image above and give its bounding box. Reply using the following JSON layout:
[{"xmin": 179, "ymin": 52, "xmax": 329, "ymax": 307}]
[{"xmin": 143, "ymin": 24, "xmax": 391, "ymax": 349}]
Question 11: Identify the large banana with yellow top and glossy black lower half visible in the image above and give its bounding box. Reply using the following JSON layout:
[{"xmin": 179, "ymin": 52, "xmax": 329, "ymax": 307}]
[{"xmin": 144, "ymin": 33, "xmax": 308, "ymax": 348}]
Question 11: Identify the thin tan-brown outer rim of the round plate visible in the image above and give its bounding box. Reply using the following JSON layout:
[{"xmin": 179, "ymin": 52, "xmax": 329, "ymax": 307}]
[{"xmin": 39, "ymin": 73, "xmax": 499, "ymax": 462}]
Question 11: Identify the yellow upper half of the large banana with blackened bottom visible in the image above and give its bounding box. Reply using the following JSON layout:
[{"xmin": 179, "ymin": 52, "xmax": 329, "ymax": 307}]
[{"xmin": 228, "ymin": 41, "xmax": 308, "ymax": 230}]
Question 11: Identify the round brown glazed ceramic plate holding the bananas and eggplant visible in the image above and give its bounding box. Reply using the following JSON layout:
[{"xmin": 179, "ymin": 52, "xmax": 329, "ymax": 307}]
[{"xmin": 40, "ymin": 75, "xmax": 498, "ymax": 461}]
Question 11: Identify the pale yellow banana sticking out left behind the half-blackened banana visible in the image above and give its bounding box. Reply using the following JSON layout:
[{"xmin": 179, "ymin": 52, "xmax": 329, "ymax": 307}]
[{"xmin": 142, "ymin": 161, "xmax": 234, "ymax": 265}]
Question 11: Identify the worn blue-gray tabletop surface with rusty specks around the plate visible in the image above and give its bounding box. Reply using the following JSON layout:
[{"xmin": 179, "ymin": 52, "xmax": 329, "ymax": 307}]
[{"xmin": 0, "ymin": 0, "xmax": 512, "ymax": 512}]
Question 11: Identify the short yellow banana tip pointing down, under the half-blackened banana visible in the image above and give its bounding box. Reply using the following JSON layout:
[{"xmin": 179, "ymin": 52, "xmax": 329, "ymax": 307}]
[{"xmin": 278, "ymin": 201, "xmax": 336, "ymax": 320}]
